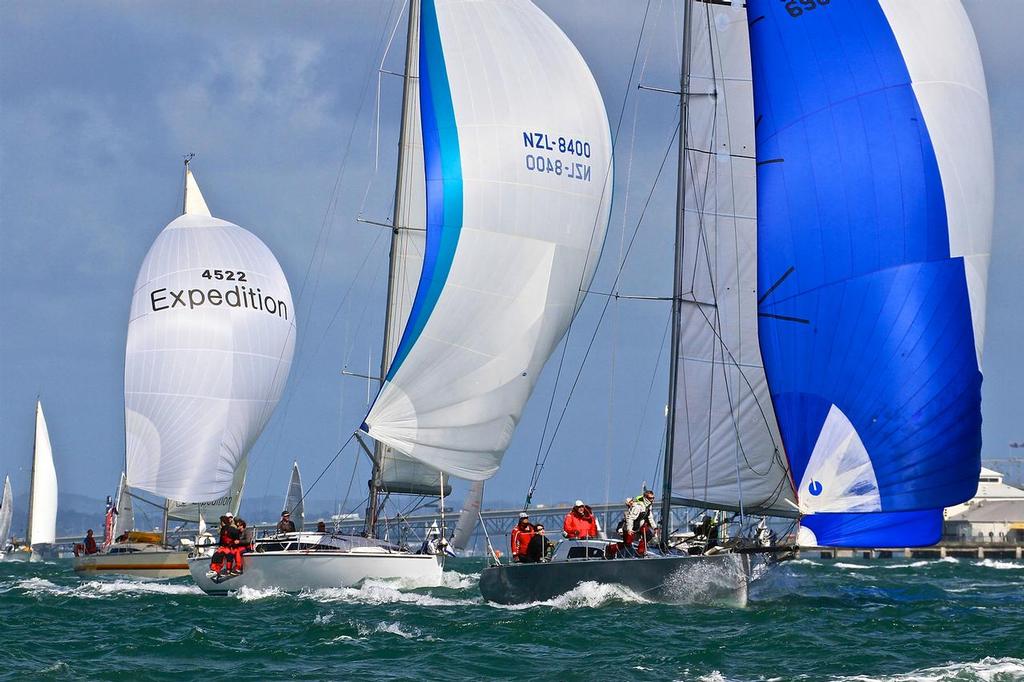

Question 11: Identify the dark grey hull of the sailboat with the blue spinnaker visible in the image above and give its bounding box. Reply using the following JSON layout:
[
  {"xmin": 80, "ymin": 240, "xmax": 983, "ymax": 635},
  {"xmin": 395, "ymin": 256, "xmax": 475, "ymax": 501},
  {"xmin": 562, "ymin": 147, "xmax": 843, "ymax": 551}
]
[{"xmin": 480, "ymin": 553, "xmax": 751, "ymax": 607}]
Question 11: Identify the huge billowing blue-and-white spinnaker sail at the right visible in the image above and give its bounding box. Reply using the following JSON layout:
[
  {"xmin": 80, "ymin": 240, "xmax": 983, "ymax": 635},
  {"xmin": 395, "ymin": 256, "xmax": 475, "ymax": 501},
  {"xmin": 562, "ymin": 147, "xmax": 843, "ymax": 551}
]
[{"xmin": 748, "ymin": 0, "xmax": 993, "ymax": 545}]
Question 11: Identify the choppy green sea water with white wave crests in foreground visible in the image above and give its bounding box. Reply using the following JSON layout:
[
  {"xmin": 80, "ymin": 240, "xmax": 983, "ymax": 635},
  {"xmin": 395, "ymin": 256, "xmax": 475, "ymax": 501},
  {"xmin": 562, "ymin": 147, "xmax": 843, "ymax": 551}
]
[{"xmin": 0, "ymin": 559, "xmax": 1024, "ymax": 682}]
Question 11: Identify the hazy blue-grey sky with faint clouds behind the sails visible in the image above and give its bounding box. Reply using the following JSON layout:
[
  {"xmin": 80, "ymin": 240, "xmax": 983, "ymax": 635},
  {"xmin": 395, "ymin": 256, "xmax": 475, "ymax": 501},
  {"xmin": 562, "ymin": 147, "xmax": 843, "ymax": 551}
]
[{"xmin": 0, "ymin": 0, "xmax": 1024, "ymax": 516}]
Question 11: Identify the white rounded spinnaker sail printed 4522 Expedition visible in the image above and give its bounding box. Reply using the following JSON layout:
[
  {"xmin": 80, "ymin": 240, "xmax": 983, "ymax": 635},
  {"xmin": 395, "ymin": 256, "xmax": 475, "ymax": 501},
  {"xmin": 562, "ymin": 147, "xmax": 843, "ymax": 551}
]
[{"xmin": 125, "ymin": 172, "xmax": 295, "ymax": 502}]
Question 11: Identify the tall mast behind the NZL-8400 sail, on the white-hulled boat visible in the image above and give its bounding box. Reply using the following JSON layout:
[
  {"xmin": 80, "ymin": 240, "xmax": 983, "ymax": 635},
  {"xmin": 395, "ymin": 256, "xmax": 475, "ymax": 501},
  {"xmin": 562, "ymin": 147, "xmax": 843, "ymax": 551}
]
[{"xmin": 367, "ymin": 0, "xmax": 420, "ymax": 538}]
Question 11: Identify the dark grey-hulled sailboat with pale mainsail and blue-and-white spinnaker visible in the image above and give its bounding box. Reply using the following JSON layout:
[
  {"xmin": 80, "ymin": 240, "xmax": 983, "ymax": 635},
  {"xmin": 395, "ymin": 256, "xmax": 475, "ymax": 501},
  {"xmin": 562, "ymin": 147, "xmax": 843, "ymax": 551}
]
[{"xmin": 480, "ymin": 0, "xmax": 992, "ymax": 603}]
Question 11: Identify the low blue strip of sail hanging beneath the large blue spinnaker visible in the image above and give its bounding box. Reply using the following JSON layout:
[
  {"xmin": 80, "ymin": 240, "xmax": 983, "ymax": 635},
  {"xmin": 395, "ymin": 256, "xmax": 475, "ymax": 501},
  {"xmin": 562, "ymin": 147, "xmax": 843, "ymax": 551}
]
[{"xmin": 798, "ymin": 509, "xmax": 942, "ymax": 548}]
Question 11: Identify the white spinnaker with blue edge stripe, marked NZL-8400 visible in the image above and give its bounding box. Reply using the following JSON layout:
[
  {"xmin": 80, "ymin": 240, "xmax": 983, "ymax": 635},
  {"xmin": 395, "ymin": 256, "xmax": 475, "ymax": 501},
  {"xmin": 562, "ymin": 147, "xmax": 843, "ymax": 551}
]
[{"xmin": 362, "ymin": 0, "xmax": 612, "ymax": 480}]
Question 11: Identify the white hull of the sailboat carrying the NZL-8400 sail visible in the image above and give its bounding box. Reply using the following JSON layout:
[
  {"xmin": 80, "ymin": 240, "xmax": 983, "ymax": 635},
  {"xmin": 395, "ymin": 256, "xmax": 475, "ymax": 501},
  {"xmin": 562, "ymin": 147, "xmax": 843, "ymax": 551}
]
[{"xmin": 188, "ymin": 549, "xmax": 443, "ymax": 595}]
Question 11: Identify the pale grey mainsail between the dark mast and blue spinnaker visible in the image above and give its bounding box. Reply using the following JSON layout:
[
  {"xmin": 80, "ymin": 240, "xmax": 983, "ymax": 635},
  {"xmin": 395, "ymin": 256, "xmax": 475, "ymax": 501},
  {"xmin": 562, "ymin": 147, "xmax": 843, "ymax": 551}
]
[{"xmin": 672, "ymin": 2, "xmax": 796, "ymax": 516}]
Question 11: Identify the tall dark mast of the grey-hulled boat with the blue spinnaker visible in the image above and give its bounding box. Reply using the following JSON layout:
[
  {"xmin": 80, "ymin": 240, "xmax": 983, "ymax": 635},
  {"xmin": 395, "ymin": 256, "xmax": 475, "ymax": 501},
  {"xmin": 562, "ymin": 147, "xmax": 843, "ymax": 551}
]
[{"xmin": 660, "ymin": 0, "xmax": 693, "ymax": 549}]
